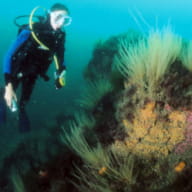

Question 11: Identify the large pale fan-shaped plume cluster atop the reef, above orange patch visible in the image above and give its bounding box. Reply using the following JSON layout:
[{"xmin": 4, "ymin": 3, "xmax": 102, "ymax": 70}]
[{"xmin": 114, "ymin": 28, "xmax": 182, "ymax": 96}]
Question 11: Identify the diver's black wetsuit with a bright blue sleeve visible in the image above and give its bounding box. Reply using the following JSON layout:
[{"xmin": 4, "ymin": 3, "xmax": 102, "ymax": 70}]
[{"xmin": 4, "ymin": 19, "xmax": 66, "ymax": 110}]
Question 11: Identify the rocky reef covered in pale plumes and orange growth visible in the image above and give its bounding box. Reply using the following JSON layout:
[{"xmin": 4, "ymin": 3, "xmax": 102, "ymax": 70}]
[{"xmin": 3, "ymin": 28, "xmax": 192, "ymax": 192}]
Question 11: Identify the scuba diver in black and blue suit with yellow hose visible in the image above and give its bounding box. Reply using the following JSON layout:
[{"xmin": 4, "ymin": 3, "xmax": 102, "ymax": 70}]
[{"xmin": 1, "ymin": 3, "xmax": 72, "ymax": 132}]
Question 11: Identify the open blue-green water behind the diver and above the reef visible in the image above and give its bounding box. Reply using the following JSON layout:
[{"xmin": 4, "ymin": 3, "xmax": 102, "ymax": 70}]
[{"xmin": 0, "ymin": 0, "xmax": 192, "ymax": 190}]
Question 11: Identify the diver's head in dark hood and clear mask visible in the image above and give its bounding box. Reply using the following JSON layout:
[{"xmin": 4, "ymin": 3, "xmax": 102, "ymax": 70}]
[{"xmin": 50, "ymin": 3, "xmax": 72, "ymax": 30}]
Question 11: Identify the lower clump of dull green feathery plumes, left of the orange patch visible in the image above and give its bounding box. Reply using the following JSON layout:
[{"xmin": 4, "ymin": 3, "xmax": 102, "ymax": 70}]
[{"xmin": 61, "ymin": 113, "xmax": 136, "ymax": 192}]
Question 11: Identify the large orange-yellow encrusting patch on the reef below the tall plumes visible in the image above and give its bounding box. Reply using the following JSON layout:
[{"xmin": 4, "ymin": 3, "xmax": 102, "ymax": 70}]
[{"xmin": 122, "ymin": 102, "xmax": 186, "ymax": 157}]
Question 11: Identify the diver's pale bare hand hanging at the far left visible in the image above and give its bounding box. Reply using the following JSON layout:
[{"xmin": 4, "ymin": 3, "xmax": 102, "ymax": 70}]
[{"xmin": 4, "ymin": 83, "xmax": 17, "ymax": 108}]
